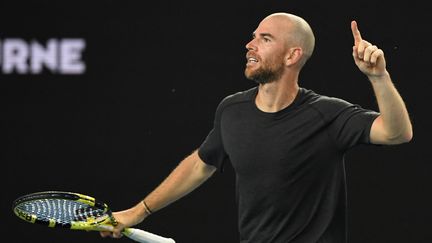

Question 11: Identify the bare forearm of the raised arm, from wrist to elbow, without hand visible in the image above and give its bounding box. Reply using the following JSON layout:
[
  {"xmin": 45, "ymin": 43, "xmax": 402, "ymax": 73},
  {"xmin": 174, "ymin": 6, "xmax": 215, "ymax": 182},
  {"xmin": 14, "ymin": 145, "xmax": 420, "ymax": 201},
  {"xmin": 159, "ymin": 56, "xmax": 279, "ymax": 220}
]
[{"xmin": 369, "ymin": 72, "xmax": 412, "ymax": 143}]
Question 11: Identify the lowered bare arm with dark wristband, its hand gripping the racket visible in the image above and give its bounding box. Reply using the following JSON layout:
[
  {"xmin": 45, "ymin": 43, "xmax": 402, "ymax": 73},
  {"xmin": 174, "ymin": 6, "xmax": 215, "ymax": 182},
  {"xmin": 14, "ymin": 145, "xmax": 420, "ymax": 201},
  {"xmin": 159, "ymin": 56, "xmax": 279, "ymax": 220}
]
[{"xmin": 101, "ymin": 151, "xmax": 216, "ymax": 238}]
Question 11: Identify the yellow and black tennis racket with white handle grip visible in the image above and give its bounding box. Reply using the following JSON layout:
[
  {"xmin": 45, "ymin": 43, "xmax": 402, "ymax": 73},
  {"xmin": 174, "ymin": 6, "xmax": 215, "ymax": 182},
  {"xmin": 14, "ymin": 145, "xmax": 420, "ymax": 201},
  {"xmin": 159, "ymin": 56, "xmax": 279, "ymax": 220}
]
[{"xmin": 12, "ymin": 191, "xmax": 175, "ymax": 243}]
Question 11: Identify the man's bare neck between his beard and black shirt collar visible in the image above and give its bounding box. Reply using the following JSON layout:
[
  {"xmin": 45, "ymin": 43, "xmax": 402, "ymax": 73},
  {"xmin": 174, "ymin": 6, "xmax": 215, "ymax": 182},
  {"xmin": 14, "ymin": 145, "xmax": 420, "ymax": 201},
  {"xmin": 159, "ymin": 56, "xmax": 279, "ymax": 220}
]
[{"xmin": 255, "ymin": 82, "xmax": 299, "ymax": 112}]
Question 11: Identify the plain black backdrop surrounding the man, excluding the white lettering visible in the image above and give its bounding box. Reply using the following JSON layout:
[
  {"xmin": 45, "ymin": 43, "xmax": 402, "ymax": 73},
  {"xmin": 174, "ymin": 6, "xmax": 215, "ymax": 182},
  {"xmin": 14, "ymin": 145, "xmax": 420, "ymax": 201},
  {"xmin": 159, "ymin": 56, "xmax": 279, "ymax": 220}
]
[{"xmin": 0, "ymin": 0, "xmax": 432, "ymax": 243}]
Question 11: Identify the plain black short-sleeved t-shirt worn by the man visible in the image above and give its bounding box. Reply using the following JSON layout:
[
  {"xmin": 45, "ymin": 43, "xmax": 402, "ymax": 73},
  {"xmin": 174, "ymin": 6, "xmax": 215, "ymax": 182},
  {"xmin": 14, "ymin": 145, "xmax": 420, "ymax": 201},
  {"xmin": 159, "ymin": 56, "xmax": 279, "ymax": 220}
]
[{"xmin": 198, "ymin": 87, "xmax": 379, "ymax": 243}]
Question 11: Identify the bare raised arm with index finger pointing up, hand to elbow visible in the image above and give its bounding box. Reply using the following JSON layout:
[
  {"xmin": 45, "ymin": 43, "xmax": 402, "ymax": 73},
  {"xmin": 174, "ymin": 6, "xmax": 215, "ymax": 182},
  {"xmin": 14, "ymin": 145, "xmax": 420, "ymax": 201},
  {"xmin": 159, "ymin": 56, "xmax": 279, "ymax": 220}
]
[{"xmin": 351, "ymin": 21, "xmax": 413, "ymax": 144}]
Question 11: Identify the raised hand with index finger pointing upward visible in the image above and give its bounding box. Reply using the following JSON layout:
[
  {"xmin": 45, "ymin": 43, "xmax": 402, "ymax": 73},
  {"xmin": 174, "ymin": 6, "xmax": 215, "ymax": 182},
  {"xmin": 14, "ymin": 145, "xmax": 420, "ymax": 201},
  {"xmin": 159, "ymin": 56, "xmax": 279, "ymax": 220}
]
[{"xmin": 351, "ymin": 20, "xmax": 387, "ymax": 79}]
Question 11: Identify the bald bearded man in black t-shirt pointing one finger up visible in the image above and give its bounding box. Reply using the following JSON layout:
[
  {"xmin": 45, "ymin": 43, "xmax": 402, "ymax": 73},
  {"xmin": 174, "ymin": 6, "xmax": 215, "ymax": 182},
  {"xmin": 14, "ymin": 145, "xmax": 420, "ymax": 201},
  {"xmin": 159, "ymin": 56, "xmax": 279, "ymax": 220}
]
[{"xmin": 101, "ymin": 13, "xmax": 412, "ymax": 243}]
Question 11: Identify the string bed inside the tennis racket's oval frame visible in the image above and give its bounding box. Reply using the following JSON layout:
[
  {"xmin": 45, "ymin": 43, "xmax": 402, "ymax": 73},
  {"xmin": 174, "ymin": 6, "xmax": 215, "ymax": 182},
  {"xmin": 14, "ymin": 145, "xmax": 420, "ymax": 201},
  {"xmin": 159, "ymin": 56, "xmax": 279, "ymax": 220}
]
[{"xmin": 17, "ymin": 199, "xmax": 105, "ymax": 225}]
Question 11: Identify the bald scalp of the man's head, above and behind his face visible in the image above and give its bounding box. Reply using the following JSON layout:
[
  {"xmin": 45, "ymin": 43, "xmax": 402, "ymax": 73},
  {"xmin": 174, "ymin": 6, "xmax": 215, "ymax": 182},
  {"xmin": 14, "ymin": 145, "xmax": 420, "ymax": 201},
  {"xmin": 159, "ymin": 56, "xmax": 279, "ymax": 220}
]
[{"xmin": 261, "ymin": 12, "xmax": 315, "ymax": 64}]
